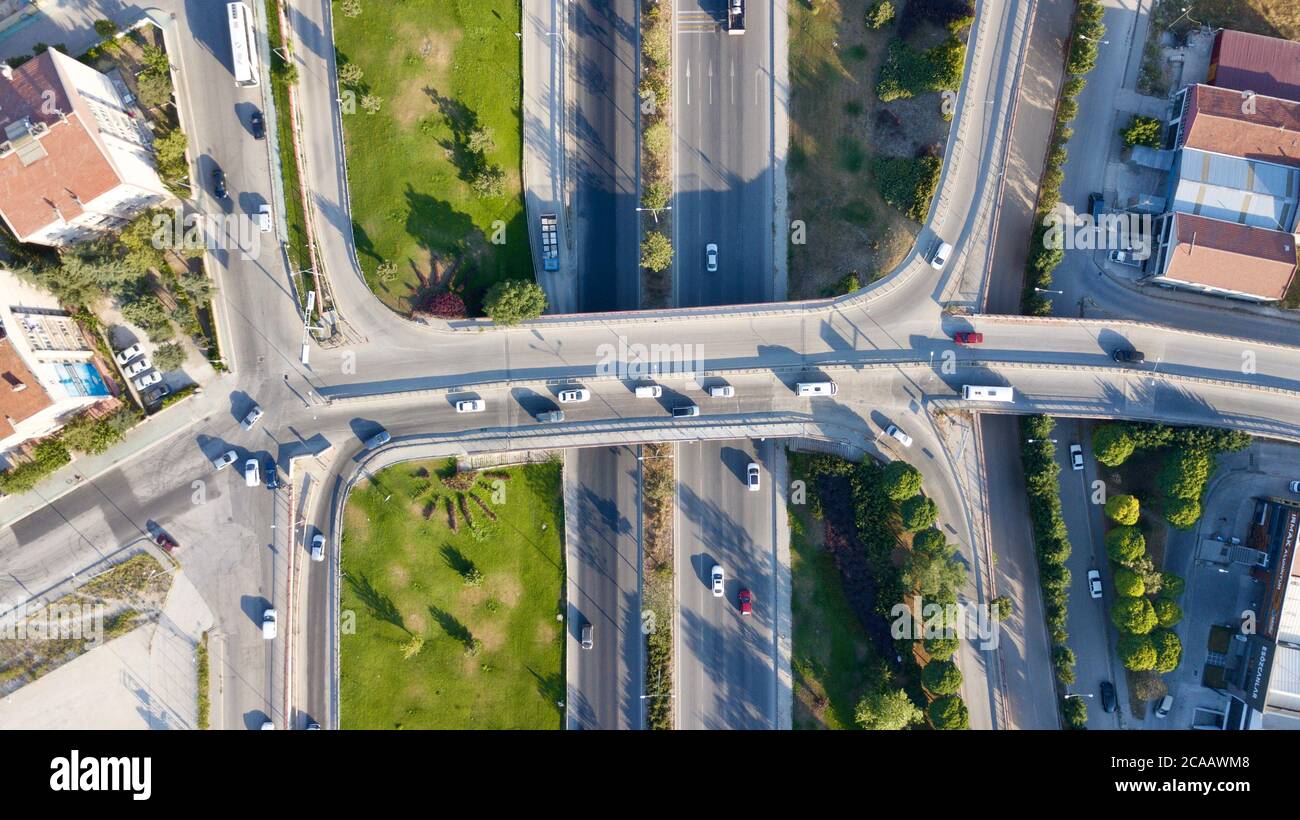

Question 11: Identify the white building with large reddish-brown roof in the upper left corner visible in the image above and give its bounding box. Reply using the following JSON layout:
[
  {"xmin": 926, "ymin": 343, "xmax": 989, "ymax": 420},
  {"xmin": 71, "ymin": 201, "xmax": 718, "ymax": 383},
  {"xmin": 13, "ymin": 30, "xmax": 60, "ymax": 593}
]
[{"xmin": 0, "ymin": 48, "xmax": 174, "ymax": 247}]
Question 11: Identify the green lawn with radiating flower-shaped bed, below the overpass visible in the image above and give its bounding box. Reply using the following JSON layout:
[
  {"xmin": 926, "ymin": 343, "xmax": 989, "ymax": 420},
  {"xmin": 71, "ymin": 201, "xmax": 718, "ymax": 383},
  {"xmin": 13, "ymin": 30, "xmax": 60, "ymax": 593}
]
[{"xmin": 341, "ymin": 460, "xmax": 564, "ymax": 729}]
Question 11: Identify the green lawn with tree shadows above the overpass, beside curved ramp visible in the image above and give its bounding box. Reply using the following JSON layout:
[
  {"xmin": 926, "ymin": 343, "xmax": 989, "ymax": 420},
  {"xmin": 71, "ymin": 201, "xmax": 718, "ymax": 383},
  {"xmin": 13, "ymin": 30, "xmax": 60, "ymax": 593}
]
[{"xmin": 334, "ymin": 0, "xmax": 532, "ymax": 312}]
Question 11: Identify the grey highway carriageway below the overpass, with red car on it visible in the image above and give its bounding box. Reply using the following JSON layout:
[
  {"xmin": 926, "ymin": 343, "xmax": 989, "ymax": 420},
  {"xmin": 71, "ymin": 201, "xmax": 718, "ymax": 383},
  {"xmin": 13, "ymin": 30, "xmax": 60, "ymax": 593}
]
[{"xmin": 673, "ymin": 441, "xmax": 784, "ymax": 729}]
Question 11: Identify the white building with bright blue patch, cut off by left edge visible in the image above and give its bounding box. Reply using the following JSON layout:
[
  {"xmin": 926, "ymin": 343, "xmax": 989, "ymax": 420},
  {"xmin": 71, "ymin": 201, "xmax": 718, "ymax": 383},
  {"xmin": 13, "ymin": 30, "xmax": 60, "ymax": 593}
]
[{"xmin": 0, "ymin": 272, "xmax": 111, "ymax": 454}]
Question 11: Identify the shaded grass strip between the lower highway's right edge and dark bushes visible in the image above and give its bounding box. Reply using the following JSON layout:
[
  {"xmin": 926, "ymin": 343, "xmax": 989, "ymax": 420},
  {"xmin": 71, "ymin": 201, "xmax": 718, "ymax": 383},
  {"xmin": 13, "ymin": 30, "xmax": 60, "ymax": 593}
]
[{"xmin": 789, "ymin": 506, "xmax": 874, "ymax": 729}]
